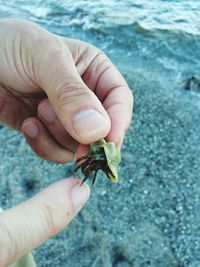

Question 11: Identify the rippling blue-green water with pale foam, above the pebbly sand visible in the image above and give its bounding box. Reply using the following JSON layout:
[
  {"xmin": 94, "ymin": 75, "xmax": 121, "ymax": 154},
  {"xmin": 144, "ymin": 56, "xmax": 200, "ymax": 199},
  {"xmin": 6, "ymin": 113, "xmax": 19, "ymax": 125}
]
[{"xmin": 0, "ymin": 0, "xmax": 200, "ymax": 81}]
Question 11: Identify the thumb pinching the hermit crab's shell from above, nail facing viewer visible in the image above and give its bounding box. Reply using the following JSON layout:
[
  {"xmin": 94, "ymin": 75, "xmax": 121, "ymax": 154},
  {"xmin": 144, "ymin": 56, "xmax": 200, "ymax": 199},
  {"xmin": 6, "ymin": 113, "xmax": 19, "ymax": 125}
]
[{"xmin": 34, "ymin": 45, "xmax": 110, "ymax": 144}]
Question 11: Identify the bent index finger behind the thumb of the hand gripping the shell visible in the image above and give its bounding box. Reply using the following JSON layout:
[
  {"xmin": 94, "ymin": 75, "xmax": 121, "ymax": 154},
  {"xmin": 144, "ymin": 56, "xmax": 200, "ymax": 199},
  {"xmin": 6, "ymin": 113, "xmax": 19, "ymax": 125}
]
[{"xmin": 62, "ymin": 38, "xmax": 133, "ymax": 144}]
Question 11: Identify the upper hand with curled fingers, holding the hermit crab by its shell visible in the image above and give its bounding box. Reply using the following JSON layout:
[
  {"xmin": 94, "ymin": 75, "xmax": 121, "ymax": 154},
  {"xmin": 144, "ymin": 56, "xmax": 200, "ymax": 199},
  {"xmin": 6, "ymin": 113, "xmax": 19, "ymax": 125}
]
[{"xmin": 0, "ymin": 19, "xmax": 133, "ymax": 163}]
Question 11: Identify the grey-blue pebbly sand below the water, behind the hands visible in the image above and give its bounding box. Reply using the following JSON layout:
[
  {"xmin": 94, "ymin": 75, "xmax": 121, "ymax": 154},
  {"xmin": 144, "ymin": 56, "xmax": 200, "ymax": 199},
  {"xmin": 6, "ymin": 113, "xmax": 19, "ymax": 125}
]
[{"xmin": 0, "ymin": 71, "xmax": 200, "ymax": 267}]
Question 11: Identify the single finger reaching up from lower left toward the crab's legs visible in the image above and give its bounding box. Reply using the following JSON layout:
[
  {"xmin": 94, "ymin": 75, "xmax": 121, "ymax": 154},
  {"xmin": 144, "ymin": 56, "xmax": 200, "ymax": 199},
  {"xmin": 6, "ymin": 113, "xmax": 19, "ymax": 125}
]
[{"xmin": 0, "ymin": 178, "xmax": 89, "ymax": 267}]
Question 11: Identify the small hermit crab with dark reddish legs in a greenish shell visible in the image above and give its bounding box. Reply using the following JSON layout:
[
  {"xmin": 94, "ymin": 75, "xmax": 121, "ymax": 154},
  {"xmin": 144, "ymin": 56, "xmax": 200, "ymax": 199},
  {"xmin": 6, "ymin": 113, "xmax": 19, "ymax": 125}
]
[{"xmin": 74, "ymin": 139, "xmax": 121, "ymax": 184}]
